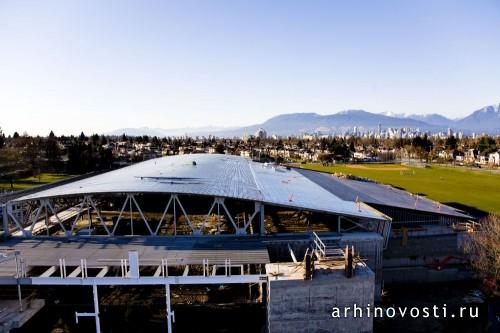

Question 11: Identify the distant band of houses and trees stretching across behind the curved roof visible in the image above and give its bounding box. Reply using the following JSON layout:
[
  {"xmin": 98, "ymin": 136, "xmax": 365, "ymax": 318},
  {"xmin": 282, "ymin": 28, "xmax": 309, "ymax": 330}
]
[{"xmin": 0, "ymin": 124, "xmax": 500, "ymax": 191}]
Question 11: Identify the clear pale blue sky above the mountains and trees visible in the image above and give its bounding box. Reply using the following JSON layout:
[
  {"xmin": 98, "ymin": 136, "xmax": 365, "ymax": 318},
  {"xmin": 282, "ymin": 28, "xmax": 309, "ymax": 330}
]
[{"xmin": 0, "ymin": 0, "xmax": 500, "ymax": 135}]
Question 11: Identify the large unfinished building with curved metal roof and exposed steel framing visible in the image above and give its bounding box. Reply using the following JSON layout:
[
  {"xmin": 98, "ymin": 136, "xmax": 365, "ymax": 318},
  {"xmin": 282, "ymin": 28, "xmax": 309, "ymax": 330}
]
[{"xmin": 0, "ymin": 154, "xmax": 470, "ymax": 332}]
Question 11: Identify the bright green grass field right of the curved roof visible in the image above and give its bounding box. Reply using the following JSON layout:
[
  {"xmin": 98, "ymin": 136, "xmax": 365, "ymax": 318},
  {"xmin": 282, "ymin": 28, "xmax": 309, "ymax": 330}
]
[{"xmin": 300, "ymin": 164, "xmax": 500, "ymax": 214}]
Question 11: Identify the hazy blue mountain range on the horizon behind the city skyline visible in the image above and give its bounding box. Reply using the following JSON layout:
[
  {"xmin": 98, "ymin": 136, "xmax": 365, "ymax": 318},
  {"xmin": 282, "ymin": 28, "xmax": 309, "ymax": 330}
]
[{"xmin": 107, "ymin": 104, "xmax": 500, "ymax": 137}]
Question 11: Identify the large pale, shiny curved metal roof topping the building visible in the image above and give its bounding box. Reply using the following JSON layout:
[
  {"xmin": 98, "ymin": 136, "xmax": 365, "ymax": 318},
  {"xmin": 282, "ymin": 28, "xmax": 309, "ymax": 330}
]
[{"xmin": 14, "ymin": 154, "xmax": 388, "ymax": 220}]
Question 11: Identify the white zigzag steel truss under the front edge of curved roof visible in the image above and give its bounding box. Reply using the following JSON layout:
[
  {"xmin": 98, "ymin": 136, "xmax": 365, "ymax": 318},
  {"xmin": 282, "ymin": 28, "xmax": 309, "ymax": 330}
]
[{"xmin": 2, "ymin": 193, "xmax": 265, "ymax": 238}]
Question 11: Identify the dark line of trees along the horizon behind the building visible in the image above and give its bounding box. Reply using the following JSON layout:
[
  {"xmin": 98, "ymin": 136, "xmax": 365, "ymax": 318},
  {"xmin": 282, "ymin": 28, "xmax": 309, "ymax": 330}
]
[{"xmin": 0, "ymin": 129, "xmax": 500, "ymax": 189}]
